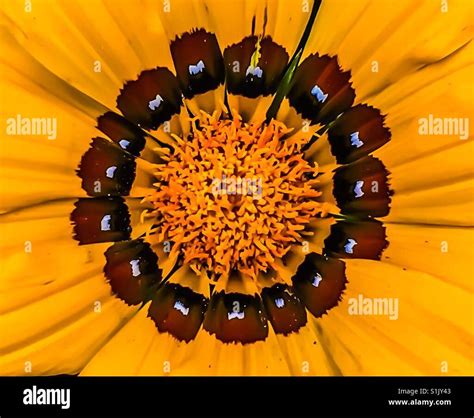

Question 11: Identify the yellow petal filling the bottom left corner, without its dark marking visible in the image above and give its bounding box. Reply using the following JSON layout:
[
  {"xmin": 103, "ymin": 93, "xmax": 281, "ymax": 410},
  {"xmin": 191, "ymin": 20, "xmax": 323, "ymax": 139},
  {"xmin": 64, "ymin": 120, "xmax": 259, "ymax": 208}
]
[{"xmin": 0, "ymin": 275, "xmax": 135, "ymax": 375}]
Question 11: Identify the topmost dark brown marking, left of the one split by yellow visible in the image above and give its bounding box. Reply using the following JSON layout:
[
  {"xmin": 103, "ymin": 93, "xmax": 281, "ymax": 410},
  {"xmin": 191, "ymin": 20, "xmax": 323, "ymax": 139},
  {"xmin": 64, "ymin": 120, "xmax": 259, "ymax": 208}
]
[{"xmin": 170, "ymin": 29, "xmax": 225, "ymax": 99}]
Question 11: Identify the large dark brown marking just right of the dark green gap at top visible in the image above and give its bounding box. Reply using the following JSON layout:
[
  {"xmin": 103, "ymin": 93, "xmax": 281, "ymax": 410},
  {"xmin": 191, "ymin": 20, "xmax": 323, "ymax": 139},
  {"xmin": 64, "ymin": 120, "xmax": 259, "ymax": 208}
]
[{"xmin": 288, "ymin": 54, "xmax": 355, "ymax": 123}]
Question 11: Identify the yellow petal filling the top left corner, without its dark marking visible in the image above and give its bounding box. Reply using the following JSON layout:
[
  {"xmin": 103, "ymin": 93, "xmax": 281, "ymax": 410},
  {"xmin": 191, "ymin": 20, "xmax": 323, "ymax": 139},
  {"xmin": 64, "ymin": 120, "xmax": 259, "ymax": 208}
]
[{"xmin": 2, "ymin": 0, "xmax": 174, "ymax": 109}]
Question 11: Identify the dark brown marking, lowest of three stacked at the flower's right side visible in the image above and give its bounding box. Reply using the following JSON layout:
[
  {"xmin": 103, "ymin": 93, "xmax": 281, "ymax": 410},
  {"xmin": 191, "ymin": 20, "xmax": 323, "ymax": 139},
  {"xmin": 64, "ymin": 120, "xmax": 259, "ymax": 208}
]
[{"xmin": 324, "ymin": 220, "xmax": 388, "ymax": 260}]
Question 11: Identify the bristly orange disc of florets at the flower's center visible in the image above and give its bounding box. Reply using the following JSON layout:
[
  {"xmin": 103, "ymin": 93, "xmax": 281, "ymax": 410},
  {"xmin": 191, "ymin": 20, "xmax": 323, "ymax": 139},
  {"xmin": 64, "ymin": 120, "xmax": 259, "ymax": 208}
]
[{"xmin": 147, "ymin": 114, "xmax": 322, "ymax": 280}]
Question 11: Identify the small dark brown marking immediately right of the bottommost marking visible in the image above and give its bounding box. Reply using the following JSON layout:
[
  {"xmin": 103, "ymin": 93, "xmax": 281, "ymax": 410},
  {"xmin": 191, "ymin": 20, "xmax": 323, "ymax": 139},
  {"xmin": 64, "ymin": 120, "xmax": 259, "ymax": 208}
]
[{"xmin": 262, "ymin": 284, "xmax": 307, "ymax": 335}]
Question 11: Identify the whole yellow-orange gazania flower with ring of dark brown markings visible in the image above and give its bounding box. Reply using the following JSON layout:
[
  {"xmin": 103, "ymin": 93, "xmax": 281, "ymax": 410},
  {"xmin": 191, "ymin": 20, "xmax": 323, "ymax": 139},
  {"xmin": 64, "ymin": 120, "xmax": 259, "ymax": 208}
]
[{"xmin": 0, "ymin": 0, "xmax": 474, "ymax": 375}]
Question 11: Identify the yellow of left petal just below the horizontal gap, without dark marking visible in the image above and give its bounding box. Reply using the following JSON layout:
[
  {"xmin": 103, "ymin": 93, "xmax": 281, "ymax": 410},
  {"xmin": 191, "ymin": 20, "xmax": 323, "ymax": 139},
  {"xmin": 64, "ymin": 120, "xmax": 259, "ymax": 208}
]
[{"xmin": 0, "ymin": 200, "xmax": 148, "ymax": 312}]
